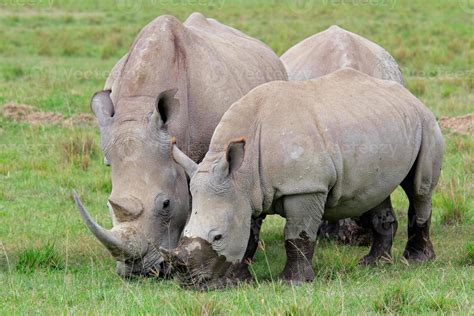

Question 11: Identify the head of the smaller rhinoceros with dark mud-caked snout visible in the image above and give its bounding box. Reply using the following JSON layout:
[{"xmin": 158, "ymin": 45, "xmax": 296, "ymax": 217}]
[{"xmin": 162, "ymin": 141, "xmax": 252, "ymax": 288}]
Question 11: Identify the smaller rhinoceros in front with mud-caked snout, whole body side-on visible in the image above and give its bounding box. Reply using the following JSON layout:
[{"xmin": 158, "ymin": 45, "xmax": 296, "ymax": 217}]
[{"xmin": 164, "ymin": 69, "xmax": 444, "ymax": 287}]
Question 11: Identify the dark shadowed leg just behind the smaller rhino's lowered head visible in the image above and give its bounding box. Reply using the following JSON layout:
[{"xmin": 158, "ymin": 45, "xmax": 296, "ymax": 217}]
[{"xmin": 232, "ymin": 214, "xmax": 267, "ymax": 281}]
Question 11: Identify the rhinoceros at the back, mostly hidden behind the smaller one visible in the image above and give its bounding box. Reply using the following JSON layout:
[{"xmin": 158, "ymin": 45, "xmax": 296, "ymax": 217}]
[{"xmin": 281, "ymin": 25, "xmax": 404, "ymax": 244}]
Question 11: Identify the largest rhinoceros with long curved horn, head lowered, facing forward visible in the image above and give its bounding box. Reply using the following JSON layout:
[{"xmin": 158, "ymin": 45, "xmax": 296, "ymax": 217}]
[{"xmin": 75, "ymin": 13, "xmax": 287, "ymax": 276}]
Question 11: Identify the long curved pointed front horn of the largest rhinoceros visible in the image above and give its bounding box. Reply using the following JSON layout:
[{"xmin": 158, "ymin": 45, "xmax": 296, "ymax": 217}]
[{"xmin": 72, "ymin": 190, "xmax": 134, "ymax": 261}]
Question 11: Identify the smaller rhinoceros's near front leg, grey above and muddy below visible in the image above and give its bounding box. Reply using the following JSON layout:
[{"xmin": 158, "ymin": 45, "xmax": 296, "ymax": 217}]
[{"xmin": 282, "ymin": 193, "xmax": 327, "ymax": 284}]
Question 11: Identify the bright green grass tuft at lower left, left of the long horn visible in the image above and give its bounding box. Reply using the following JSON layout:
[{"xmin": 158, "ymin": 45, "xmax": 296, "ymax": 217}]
[{"xmin": 16, "ymin": 243, "xmax": 64, "ymax": 273}]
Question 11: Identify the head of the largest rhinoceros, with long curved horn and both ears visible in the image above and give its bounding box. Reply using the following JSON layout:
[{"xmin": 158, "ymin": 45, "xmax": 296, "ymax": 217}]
[{"xmin": 75, "ymin": 90, "xmax": 193, "ymax": 277}]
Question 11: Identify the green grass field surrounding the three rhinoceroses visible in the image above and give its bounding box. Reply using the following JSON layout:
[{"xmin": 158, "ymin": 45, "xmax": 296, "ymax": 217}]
[{"xmin": 0, "ymin": 0, "xmax": 474, "ymax": 315}]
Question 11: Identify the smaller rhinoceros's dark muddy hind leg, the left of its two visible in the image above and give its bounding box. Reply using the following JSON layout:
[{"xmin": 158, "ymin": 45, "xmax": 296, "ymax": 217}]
[{"xmin": 359, "ymin": 196, "xmax": 398, "ymax": 265}]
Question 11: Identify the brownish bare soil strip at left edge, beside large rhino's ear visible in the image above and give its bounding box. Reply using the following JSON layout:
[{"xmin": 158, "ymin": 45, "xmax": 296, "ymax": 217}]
[{"xmin": 1, "ymin": 102, "xmax": 96, "ymax": 127}]
